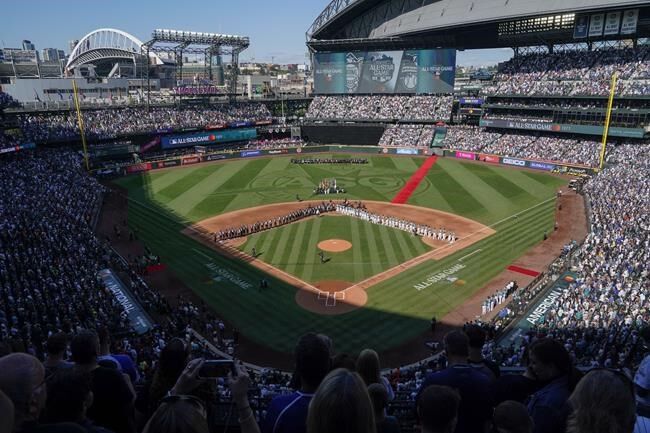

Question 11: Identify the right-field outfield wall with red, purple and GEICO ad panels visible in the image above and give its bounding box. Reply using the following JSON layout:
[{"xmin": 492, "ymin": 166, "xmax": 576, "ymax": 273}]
[{"xmin": 445, "ymin": 149, "xmax": 598, "ymax": 176}]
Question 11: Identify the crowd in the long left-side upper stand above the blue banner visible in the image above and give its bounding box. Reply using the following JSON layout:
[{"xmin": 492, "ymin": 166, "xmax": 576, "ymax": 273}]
[{"xmin": 19, "ymin": 103, "xmax": 272, "ymax": 143}]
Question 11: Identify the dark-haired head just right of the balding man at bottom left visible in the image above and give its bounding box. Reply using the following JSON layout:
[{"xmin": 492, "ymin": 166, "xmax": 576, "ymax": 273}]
[{"xmin": 45, "ymin": 369, "xmax": 93, "ymax": 423}]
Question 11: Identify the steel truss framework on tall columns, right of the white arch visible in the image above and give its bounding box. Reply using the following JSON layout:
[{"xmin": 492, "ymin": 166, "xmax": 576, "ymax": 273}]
[{"xmin": 142, "ymin": 29, "xmax": 250, "ymax": 107}]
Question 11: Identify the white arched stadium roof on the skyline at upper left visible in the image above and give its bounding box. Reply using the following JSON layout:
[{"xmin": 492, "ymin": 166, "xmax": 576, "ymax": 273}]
[{"xmin": 65, "ymin": 28, "xmax": 163, "ymax": 71}]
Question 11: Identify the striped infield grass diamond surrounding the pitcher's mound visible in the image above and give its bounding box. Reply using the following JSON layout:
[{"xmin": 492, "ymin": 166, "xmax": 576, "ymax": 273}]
[{"xmin": 240, "ymin": 215, "xmax": 431, "ymax": 283}]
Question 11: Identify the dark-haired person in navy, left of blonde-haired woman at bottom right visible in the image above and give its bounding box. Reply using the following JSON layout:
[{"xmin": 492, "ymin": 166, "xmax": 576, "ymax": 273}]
[{"xmin": 528, "ymin": 338, "xmax": 580, "ymax": 433}]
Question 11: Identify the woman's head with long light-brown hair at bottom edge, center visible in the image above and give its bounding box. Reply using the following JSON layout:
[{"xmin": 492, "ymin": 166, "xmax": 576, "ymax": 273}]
[{"xmin": 307, "ymin": 368, "xmax": 375, "ymax": 433}]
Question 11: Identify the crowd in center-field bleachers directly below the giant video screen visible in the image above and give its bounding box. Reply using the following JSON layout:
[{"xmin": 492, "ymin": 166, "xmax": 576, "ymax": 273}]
[{"xmin": 305, "ymin": 95, "xmax": 453, "ymax": 122}]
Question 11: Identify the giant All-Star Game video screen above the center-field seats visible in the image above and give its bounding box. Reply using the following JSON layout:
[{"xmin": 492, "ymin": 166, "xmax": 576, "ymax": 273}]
[{"xmin": 314, "ymin": 49, "xmax": 456, "ymax": 94}]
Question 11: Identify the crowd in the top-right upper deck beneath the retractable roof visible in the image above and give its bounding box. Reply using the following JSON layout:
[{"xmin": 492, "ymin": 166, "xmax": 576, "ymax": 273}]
[{"xmin": 483, "ymin": 46, "xmax": 650, "ymax": 95}]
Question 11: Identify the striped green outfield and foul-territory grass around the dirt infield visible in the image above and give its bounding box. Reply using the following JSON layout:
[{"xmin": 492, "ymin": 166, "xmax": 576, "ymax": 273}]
[{"xmin": 116, "ymin": 154, "xmax": 565, "ymax": 353}]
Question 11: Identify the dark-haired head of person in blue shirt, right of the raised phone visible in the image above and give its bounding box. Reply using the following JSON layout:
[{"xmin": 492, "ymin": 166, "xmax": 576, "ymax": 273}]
[{"xmin": 295, "ymin": 333, "xmax": 331, "ymax": 389}]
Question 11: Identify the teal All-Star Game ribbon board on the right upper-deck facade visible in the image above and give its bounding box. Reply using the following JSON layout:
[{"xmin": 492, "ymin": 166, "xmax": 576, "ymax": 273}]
[{"xmin": 479, "ymin": 119, "xmax": 645, "ymax": 138}]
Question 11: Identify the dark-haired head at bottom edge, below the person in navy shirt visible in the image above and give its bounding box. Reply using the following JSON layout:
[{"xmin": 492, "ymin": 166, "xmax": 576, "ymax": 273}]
[{"xmin": 417, "ymin": 385, "xmax": 460, "ymax": 433}]
